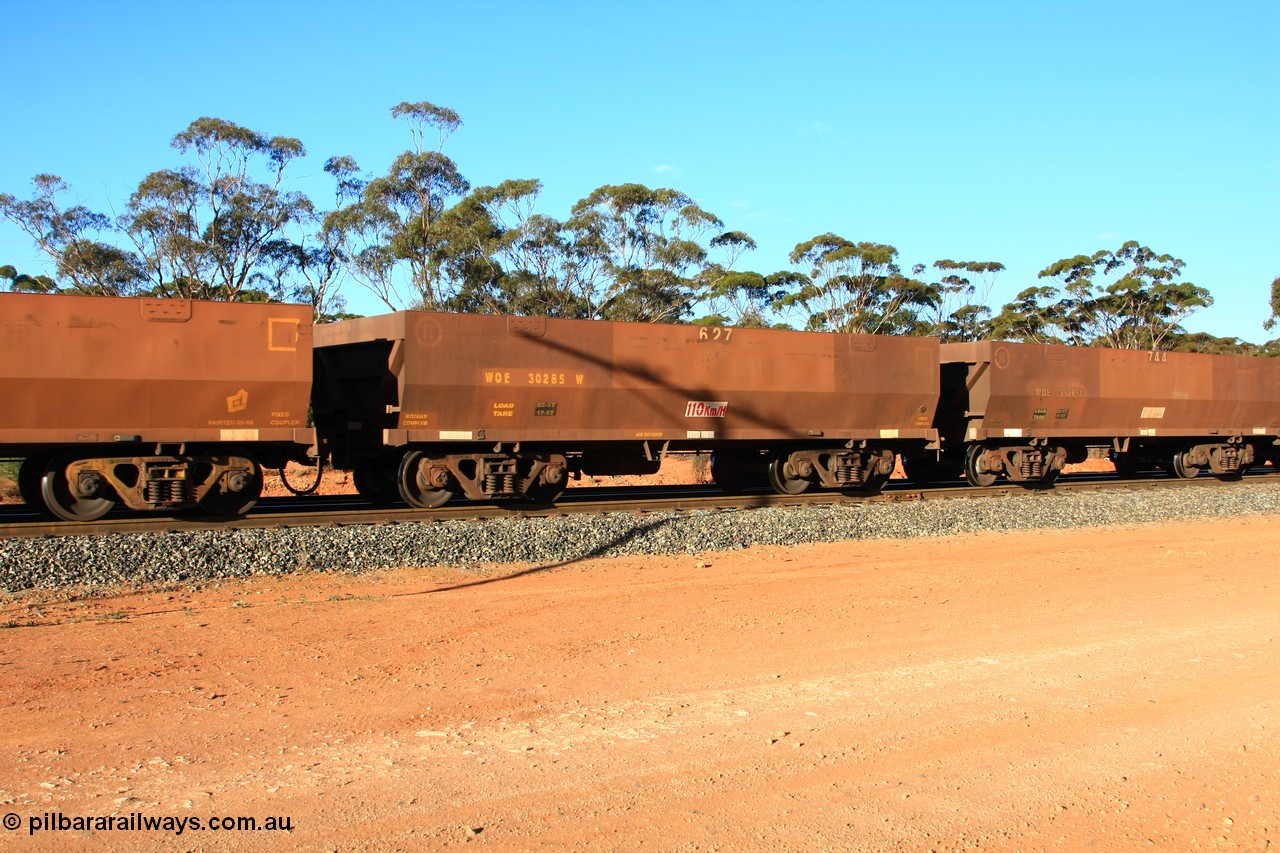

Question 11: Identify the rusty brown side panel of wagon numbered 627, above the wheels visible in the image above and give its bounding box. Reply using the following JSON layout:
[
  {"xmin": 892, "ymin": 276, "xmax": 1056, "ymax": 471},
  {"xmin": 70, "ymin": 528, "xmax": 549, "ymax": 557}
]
[{"xmin": 337, "ymin": 313, "xmax": 938, "ymax": 444}]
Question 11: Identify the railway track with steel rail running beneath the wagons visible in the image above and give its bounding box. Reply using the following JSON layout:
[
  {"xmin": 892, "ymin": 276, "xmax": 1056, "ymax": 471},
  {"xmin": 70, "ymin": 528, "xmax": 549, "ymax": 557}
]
[{"xmin": 0, "ymin": 469, "xmax": 1276, "ymax": 538}]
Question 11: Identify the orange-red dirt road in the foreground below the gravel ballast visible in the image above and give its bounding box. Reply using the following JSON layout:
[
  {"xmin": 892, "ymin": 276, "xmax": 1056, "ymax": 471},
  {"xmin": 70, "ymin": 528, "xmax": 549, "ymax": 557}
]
[{"xmin": 0, "ymin": 517, "xmax": 1280, "ymax": 850}]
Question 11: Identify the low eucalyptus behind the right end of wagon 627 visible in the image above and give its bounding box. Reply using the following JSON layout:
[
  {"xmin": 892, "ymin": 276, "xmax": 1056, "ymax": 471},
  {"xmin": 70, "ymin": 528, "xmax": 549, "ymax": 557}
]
[{"xmin": 777, "ymin": 233, "xmax": 940, "ymax": 334}]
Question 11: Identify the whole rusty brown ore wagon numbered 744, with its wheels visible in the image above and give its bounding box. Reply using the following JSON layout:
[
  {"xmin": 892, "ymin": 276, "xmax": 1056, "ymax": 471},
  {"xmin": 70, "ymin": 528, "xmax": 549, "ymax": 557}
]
[{"xmin": 938, "ymin": 341, "xmax": 1280, "ymax": 484}]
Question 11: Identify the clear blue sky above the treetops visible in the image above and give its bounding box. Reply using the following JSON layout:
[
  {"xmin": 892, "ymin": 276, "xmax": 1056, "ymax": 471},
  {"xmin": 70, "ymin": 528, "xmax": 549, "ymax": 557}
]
[{"xmin": 0, "ymin": 0, "xmax": 1280, "ymax": 341}]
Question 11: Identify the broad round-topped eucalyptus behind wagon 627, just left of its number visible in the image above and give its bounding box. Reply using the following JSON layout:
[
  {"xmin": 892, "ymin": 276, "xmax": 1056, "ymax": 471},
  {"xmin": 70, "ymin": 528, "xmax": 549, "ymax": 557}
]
[{"xmin": 564, "ymin": 183, "xmax": 724, "ymax": 323}]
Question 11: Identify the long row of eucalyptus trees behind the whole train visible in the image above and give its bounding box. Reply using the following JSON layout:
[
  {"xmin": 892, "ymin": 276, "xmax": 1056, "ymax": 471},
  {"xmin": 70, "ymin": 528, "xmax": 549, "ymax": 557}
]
[{"xmin": 0, "ymin": 101, "xmax": 1280, "ymax": 351}]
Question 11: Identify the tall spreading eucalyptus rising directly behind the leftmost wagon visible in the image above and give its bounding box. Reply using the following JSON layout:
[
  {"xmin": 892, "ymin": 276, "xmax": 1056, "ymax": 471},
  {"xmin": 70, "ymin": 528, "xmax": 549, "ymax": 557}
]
[{"xmin": 119, "ymin": 117, "xmax": 312, "ymax": 300}]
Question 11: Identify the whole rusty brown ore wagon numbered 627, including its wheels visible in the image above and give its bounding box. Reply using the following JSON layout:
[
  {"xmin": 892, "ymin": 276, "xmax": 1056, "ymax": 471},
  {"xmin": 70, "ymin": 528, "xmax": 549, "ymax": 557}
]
[{"xmin": 315, "ymin": 311, "xmax": 938, "ymax": 506}]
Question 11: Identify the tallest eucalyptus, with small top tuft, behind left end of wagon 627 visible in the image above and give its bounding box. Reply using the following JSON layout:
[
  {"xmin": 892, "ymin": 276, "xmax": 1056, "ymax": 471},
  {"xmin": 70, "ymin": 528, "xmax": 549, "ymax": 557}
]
[{"xmin": 324, "ymin": 101, "xmax": 471, "ymax": 310}]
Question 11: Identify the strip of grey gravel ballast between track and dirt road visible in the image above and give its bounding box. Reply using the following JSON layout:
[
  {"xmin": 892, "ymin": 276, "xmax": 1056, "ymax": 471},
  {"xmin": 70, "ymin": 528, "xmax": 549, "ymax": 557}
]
[{"xmin": 0, "ymin": 482, "xmax": 1280, "ymax": 593}]
